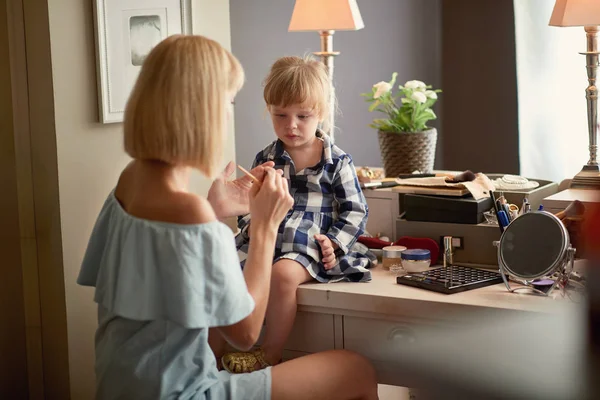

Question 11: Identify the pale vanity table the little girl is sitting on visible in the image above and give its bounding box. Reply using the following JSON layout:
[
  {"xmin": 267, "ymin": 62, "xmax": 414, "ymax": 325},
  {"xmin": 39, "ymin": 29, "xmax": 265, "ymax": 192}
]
[{"xmin": 284, "ymin": 265, "xmax": 567, "ymax": 386}]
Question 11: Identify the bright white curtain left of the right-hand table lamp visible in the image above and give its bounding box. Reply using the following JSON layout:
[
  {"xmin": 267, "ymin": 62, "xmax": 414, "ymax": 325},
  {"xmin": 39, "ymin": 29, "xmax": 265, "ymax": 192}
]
[{"xmin": 514, "ymin": 0, "xmax": 589, "ymax": 182}]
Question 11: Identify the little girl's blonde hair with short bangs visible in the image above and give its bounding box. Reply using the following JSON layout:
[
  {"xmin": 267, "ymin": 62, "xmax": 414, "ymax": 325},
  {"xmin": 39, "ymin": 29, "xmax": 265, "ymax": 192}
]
[{"xmin": 263, "ymin": 56, "xmax": 335, "ymax": 132}]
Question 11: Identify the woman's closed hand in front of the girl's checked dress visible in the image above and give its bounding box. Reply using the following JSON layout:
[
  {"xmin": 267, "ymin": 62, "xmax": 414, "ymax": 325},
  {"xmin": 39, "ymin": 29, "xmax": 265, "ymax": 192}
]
[{"xmin": 250, "ymin": 168, "xmax": 294, "ymax": 238}]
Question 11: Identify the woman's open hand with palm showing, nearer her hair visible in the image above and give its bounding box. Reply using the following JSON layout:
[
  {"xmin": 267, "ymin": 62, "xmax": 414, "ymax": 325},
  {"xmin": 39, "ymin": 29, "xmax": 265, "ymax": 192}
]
[{"xmin": 207, "ymin": 161, "xmax": 275, "ymax": 219}]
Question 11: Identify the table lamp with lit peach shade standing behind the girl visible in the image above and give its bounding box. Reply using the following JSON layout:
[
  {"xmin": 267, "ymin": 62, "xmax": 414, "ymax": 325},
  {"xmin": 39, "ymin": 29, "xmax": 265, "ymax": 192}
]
[{"xmin": 288, "ymin": 0, "xmax": 365, "ymax": 141}]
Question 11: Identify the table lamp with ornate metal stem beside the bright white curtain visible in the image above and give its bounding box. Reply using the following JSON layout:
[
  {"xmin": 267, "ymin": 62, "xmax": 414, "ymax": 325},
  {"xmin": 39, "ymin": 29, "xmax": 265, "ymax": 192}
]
[{"xmin": 549, "ymin": 0, "xmax": 600, "ymax": 189}]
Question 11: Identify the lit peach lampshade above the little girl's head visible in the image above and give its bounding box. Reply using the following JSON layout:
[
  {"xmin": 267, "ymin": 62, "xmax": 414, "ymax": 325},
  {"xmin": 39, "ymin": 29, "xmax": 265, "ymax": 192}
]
[{"xmin": 288, "ymin": 0, "xmax": 364, "ymax": 32}]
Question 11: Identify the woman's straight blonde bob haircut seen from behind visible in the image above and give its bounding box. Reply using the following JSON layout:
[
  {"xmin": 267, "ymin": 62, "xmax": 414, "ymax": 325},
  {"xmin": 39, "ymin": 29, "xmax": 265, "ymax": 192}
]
[{"xmin": 124, "ymin": 35, "xmax": 244, "ymax": 177}]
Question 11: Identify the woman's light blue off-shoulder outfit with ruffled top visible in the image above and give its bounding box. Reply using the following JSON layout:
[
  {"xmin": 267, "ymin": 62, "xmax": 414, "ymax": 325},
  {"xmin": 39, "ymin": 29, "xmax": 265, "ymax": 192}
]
[{"xmin": 77, "ymin": 192, "xmax": 270, "ymax": 400}]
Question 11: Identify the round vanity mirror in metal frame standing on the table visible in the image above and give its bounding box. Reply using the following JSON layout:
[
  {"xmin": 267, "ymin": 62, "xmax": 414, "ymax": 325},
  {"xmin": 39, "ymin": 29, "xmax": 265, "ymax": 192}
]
[{"xmin": 496, "ymin": 211, "xmax": 575, "ymax": 294}]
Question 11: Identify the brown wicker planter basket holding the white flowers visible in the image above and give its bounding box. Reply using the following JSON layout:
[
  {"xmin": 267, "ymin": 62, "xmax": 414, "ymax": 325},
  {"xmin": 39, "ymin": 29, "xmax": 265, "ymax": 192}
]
[{"xmin": 378, "ymin": 128, "xmax": 437, "ymax": 177}]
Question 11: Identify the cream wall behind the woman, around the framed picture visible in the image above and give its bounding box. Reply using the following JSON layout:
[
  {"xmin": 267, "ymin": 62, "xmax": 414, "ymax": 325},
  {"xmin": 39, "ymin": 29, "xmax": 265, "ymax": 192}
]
[{"xmin": 48, "ymin": 0, "xmax": 235, "ymax": 400}]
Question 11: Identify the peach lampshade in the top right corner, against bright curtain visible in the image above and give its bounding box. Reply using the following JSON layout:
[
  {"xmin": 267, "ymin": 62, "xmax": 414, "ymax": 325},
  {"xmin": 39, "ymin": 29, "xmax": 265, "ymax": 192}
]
[{"xmin": 549, "ymin": 0, "xmax": 600, "ymax": 26}]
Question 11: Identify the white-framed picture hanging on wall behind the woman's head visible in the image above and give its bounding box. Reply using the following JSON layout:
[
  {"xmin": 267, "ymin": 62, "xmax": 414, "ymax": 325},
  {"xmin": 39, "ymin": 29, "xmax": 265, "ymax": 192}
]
[{"xmin": 94, "ymin": 0, "xmax": 192, "ymax": 124}]
